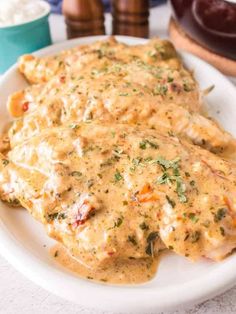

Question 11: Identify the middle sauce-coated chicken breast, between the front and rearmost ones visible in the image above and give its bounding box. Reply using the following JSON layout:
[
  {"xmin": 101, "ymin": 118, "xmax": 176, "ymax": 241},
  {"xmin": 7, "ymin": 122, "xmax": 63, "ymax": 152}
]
[{"xmin": 8, "ymin": 45, "xmax": 235, "ymax": 152}]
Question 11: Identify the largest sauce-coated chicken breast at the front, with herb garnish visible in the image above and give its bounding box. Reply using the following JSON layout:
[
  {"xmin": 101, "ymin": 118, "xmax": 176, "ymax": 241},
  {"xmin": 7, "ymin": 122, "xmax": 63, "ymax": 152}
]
[{"xmin": 0, "ymin": 122, "xmax": 236, "ymax": 267}]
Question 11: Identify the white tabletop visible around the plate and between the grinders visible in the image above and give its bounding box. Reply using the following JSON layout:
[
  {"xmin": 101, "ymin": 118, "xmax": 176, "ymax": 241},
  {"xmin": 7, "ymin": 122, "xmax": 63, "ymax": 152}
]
[{"xmin": 0, "ymin": 5, "xmax": 236, "ymax": 314}]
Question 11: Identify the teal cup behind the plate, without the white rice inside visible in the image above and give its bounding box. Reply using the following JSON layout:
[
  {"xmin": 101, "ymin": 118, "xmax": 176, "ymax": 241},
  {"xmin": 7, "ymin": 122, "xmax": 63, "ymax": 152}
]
[{"xmin": 0, "ymin": 1, "xmax": 52, "ymax": 74}]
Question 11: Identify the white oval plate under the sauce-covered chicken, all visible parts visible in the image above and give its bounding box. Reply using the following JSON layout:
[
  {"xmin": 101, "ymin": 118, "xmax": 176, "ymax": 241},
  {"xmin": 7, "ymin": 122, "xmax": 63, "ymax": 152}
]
[{"xmin": 0, "ymin": 36, "xmax": 236, "ymax": 313}]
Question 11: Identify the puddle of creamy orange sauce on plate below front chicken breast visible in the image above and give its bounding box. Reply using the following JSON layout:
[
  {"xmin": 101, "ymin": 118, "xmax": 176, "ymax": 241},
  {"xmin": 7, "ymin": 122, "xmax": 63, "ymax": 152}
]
[{"xmin": 50, "ymin": 244, "xmax": 158, "ymax": 284}]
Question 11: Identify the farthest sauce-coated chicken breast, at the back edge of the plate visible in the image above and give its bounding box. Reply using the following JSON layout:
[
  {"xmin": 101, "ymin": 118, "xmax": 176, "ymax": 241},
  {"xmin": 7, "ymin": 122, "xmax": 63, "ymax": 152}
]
[{"xmin": 19, "ymin": 37, "xmax": 182, "ymax": 84}]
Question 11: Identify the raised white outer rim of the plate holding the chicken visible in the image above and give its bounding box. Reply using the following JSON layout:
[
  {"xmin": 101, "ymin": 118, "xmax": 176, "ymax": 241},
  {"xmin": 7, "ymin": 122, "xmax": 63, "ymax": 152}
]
[{"xmin": 0, "ymin": 36, "xmax": 236, "ymax": 313}]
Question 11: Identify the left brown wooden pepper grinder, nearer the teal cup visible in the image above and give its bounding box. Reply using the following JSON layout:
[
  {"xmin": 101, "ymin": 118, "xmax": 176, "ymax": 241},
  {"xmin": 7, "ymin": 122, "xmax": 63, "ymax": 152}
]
[{"xmin": 62, "ymin": 0, "xmax": 105, "ymax": 38}]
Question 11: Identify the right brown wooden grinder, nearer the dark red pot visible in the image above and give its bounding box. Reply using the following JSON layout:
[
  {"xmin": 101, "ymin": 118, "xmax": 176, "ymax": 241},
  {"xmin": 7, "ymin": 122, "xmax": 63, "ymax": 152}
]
[{"xmin": 112, "ymin": 0, "xmax": 149, "ymax": 37}]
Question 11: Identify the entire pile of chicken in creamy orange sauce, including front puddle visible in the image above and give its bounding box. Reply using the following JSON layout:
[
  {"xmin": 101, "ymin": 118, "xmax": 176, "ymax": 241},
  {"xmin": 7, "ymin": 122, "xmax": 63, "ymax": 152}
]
[{"xmin": 0, "ymin": 39, "xmax": 236, "ymax": 284}]
